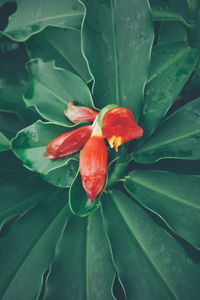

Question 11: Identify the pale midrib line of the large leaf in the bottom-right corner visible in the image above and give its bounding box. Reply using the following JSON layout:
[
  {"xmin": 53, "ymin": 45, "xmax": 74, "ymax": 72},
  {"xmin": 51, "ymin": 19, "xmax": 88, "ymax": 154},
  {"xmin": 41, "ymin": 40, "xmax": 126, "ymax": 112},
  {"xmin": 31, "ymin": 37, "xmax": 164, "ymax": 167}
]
[{"xmin": 112, "ymin": 194, "xmax": 178, "ymax": 299}]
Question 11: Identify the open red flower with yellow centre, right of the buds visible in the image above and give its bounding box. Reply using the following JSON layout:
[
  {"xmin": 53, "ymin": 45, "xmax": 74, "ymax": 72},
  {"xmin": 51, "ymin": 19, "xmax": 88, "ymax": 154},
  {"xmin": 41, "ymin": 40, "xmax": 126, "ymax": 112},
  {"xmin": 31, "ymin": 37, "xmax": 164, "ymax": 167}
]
[{"xmin": 102, "ymin": 107, "xmax": 143, "ymax": 151}]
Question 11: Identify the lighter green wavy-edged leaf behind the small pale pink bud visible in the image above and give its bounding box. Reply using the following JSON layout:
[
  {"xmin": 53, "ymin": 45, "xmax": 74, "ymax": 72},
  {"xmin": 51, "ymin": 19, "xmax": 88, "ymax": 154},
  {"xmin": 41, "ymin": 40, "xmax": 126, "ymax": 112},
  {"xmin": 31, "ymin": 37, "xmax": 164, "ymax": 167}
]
[{"xmin": 25, "ymin": 59, "xmax": 93, "ymax": 126}]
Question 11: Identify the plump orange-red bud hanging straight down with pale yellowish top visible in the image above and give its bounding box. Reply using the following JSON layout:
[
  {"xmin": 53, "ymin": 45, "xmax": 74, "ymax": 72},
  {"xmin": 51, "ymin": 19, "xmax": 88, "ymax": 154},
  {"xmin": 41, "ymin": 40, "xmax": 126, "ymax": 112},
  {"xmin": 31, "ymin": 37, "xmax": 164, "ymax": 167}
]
[{"xmin": 79, "ymin": 124, "xmax": 108, "ymax": 201}]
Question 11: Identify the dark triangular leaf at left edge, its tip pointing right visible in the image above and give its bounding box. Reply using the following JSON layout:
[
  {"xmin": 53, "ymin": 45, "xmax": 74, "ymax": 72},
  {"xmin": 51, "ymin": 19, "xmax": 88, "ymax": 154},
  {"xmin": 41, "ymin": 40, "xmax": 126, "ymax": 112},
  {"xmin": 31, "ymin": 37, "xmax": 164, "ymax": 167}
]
[{"xmin": 0, "ymin": 151, "xmax": 53, "ymax": 226}]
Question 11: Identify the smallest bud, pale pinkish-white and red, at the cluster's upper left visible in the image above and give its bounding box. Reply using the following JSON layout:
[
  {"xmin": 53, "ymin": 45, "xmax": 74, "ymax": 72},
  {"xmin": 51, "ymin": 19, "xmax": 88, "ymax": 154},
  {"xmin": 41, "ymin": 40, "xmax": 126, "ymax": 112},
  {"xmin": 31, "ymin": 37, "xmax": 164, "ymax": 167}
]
[{"xmin": 64, "ymin": 101, "xmax": 98, "ymax": 123}]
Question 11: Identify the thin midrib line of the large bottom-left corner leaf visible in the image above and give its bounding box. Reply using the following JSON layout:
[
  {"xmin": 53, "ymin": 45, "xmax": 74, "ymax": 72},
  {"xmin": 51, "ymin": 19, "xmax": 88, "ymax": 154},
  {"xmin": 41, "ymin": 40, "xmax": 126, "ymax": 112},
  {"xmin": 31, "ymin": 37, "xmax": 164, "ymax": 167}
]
[{"xmin": 1, "ymin": 191, "xmax": 65, "ymax": 300}]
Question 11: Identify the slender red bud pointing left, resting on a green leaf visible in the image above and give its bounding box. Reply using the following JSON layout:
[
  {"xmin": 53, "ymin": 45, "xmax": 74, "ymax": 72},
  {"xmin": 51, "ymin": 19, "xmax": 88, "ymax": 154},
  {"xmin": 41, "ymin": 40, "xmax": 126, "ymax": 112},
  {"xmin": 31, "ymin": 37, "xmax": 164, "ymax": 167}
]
[{"xmin": 44, "ymin": 126, "xmax": 92, "ymax": 159}]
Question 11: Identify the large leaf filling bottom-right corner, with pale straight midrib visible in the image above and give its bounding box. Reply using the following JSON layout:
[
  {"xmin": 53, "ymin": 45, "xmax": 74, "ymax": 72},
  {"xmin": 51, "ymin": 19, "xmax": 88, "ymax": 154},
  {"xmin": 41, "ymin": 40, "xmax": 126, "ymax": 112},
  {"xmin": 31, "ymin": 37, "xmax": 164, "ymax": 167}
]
[{"xmin": 102, "ymin": 190, "xmax": 200, "ymax": 300}]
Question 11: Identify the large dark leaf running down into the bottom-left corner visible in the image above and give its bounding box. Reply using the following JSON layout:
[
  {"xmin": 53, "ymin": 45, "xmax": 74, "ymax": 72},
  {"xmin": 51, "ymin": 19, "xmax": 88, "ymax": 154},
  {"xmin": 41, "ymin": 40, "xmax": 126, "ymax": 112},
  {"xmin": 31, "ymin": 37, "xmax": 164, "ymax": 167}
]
[{"xmin": 0, "ymin": 189, "xmax": 68, "ymax": 300}]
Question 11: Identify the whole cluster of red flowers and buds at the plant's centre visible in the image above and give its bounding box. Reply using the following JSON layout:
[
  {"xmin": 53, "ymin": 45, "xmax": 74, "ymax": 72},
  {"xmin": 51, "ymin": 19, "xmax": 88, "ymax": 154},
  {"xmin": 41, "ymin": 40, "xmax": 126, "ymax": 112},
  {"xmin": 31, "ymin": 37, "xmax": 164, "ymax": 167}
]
[{"xmin": 44, "ymin": 101, "xmax": 143, "ymax": 201}]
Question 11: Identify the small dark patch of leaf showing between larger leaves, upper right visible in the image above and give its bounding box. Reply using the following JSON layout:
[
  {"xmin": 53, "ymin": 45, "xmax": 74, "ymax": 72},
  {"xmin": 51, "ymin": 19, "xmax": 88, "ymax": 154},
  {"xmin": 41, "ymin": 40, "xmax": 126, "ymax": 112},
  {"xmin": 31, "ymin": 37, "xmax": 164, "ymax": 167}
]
[{"xmin": 158, "ymin": 22, "xmax": 187, "ymax": 45}]
